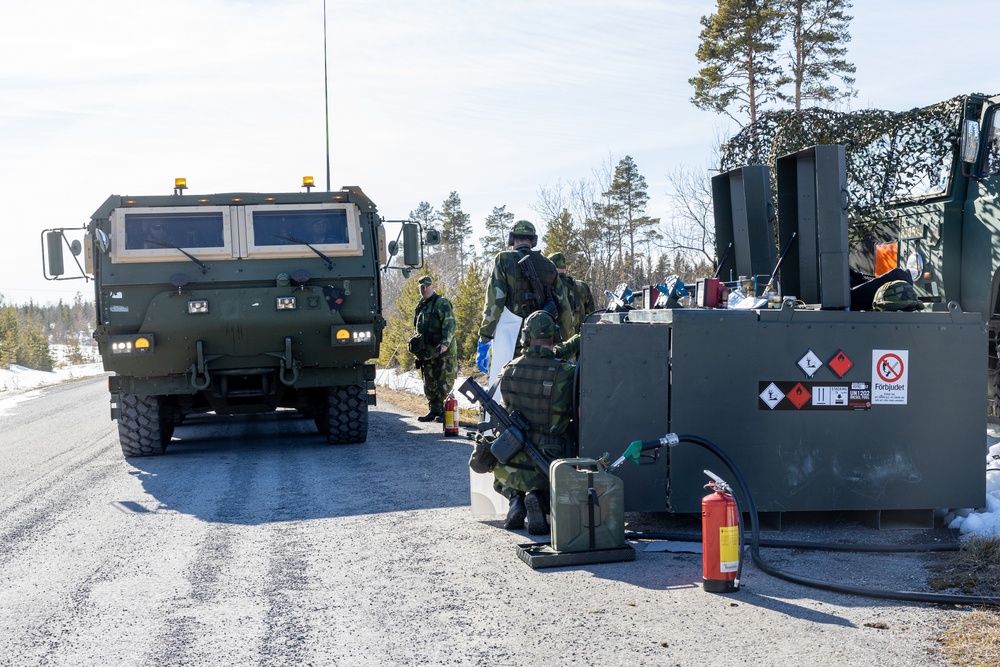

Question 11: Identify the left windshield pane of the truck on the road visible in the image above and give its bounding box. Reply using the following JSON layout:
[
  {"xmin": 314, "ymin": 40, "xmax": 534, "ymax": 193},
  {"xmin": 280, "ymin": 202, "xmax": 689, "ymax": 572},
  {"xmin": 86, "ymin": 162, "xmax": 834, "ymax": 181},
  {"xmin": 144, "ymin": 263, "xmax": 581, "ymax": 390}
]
[{"xmin": 125, "ymin": 211, "xmax": 225, "ymax": 250}]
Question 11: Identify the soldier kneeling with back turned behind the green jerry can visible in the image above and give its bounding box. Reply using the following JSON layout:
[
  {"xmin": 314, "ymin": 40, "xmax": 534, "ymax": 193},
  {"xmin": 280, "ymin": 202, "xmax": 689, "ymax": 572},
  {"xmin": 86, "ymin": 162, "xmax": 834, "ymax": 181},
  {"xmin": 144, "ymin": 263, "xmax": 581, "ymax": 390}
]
[{"xmin": 493, "ymin": 311, "xmax": 577, "ymax": 535}]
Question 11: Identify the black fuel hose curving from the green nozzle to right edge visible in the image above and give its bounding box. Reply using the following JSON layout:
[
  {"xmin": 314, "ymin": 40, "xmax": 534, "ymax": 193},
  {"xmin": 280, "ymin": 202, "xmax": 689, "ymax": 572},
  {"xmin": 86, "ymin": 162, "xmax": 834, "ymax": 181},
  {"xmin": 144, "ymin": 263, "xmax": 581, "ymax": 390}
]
[{"xmin": 671, "ymin": 435, "xmax": 1000, "ymax": 607}]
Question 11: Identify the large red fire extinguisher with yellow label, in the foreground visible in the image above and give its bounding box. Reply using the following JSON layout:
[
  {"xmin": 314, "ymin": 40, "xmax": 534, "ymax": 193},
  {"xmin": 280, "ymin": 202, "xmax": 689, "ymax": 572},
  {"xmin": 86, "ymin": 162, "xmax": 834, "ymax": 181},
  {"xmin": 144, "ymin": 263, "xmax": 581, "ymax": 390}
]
[{"xmin": 701, "ymin": 470, "xmax": 740, "ymax": 593}]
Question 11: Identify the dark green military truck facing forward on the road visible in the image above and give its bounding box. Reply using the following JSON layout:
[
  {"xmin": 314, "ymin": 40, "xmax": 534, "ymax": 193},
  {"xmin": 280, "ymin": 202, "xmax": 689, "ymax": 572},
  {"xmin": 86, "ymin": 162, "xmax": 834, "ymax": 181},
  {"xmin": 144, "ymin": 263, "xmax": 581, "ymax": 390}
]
[{"xmin": 42, "ymin": 179, "xmax": 433, "ymax": 457}]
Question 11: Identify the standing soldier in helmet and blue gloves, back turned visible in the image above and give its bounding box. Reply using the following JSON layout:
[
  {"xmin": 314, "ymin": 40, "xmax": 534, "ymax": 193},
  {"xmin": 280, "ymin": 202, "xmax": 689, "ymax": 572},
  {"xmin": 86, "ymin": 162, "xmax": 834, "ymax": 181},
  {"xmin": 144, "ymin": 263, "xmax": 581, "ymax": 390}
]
[{"xmin": 476, "ymin": 220, "xmax": 574, "ymax": 373}]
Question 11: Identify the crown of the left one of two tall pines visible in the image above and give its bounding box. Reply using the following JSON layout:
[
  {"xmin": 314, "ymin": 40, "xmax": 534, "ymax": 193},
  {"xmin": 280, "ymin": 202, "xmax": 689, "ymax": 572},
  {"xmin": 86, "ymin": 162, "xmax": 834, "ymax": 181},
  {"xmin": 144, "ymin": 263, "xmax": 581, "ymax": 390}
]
[{"xmin": 688, "ymin": 0, "xmax": 788, "ymax": 126}]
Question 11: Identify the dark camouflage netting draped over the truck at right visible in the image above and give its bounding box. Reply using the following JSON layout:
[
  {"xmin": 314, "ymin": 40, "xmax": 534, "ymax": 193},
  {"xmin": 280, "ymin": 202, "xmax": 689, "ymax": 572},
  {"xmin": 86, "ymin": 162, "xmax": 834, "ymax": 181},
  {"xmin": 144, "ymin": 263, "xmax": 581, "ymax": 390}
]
[{"xmin": 721, "ymin": 96, "xmax": 980, "ymax": 239}]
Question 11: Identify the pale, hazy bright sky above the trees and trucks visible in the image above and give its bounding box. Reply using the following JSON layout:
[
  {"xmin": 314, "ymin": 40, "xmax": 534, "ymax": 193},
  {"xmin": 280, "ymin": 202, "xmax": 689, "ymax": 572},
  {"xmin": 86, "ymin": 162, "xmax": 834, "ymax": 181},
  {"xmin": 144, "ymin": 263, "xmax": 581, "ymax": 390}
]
[{"xmin": 0, "ymin": 0, "xmax": 1000, "ymax": 303}]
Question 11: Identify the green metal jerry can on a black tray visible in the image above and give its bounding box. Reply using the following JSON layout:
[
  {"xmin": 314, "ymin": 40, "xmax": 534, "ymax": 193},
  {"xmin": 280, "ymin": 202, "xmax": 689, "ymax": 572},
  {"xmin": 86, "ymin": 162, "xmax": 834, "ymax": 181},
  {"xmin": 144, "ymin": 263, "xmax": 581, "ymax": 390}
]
[{"xmin": 549, "ymin": 459, "xmax": 625, "ymax": 552}]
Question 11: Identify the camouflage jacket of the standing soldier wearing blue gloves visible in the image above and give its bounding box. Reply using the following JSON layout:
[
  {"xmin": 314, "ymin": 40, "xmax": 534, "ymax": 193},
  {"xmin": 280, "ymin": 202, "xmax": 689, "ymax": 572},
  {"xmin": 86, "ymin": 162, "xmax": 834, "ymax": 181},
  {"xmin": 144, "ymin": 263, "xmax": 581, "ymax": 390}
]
[{"xmin": 479, "ymin": 245, "xmax": 576, "ymax": 340}]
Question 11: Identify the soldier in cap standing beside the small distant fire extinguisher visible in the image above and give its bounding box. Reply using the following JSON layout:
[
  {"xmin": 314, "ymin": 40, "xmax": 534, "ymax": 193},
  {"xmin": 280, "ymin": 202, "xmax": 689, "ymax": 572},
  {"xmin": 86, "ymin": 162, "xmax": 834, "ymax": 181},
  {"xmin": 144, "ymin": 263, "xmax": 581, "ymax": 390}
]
[{"xmin": 410, "ymin": 276, "xmax": 458, "ymax": 422}]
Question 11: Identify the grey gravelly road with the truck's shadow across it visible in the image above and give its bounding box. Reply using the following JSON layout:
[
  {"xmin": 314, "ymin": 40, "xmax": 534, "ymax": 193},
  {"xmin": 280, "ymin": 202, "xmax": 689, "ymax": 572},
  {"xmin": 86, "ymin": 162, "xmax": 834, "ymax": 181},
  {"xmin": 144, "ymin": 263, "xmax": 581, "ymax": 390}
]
[{"xmin": 0, "ymin": 378, "xmax": 966, "ymax": 667}]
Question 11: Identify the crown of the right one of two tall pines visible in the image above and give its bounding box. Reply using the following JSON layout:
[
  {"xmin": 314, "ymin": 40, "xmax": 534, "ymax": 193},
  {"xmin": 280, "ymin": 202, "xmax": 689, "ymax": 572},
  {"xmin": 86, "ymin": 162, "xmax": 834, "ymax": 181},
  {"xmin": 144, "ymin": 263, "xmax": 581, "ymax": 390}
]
[{"xmin": 779, "ymin": 0, "xmax": 857, "ymax": 111}]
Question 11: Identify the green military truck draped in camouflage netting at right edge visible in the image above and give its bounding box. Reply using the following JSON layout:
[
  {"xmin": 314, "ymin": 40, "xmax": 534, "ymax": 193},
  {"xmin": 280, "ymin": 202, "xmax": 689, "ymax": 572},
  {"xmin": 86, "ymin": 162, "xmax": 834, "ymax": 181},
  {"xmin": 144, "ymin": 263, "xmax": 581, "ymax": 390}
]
[{"xmin": 723, "ymin": 93, "xmax": 1000, "ymax": 416}]
